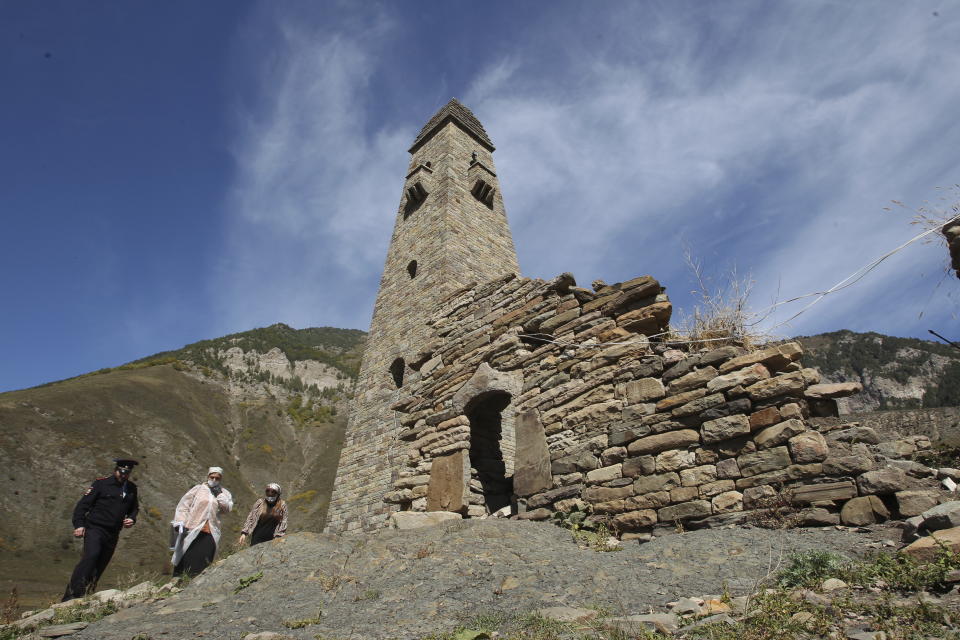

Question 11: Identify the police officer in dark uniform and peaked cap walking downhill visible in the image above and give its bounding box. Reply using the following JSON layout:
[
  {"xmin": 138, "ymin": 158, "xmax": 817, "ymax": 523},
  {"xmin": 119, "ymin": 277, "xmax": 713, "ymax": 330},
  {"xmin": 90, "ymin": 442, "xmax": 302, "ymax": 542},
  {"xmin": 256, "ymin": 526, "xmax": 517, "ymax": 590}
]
[{"xmin": 63, "ymin": 458, "xmax": 140, "ymax": 601}]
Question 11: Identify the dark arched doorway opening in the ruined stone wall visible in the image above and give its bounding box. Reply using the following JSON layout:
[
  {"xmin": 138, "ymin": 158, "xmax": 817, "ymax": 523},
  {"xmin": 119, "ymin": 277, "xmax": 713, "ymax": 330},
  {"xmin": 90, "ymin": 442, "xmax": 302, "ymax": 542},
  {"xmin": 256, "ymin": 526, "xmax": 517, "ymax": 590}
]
[{"xmin": 464, "ymin": 391, "xmax": 514, "ymax": 513}]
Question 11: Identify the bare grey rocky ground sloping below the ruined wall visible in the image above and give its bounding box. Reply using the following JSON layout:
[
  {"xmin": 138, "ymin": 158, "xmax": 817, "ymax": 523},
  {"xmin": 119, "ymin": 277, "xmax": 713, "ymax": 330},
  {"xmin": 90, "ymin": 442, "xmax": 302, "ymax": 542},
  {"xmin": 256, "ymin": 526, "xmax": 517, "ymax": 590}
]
[{"xmin": 9, "ymin": 519, "xmax": 957, "ymax": 640}]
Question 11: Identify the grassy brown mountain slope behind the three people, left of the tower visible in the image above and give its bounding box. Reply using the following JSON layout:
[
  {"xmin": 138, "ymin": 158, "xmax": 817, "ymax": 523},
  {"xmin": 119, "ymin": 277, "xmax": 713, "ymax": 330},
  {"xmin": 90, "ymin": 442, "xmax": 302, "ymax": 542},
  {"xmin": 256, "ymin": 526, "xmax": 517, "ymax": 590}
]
[{"xmin": 0, "ymin": 325, "xmax": 364, "ymax": 602}]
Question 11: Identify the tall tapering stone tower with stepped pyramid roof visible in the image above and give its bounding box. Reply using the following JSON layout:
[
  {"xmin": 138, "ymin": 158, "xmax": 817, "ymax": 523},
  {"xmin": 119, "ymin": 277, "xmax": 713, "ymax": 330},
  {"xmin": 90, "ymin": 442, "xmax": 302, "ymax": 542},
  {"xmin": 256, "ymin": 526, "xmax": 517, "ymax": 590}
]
[{"xmin": 327, "ymin": 99, "xmax": 519, "ymax": 531}]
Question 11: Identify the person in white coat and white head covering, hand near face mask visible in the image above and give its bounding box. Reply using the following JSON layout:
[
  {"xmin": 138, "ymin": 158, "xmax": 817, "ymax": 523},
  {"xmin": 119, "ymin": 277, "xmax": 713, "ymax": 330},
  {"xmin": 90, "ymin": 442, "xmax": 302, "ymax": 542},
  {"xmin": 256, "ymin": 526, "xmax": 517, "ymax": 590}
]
[{"xmin": 170, "ymin": 467, "xmax": 233, "ymax": 576}]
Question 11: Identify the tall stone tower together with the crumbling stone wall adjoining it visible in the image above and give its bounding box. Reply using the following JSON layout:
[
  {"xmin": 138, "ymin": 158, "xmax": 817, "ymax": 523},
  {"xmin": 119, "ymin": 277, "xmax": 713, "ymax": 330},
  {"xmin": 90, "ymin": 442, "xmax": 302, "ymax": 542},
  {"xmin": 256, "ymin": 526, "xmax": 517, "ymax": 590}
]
[{"xmin": 327, "ymin": 100, "xmax": 956, "ymax": 537}]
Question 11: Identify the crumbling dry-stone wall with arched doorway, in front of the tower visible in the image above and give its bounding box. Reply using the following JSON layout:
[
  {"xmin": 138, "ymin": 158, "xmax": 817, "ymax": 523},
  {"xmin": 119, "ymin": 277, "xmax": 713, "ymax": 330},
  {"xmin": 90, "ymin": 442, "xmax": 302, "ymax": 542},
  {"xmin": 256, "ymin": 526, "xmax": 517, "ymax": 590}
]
[{"xmin": 384, "ymin": 274, "xmax": 929, "ymax": 534}]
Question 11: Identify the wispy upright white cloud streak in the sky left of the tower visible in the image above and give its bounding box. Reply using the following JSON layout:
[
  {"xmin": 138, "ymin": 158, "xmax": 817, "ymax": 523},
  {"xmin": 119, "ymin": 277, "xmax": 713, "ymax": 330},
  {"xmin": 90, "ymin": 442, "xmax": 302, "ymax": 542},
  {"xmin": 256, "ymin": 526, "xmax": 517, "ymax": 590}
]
[{"xmin": 214, "ymin": 5, "xmax": 413, "ymax": 328}]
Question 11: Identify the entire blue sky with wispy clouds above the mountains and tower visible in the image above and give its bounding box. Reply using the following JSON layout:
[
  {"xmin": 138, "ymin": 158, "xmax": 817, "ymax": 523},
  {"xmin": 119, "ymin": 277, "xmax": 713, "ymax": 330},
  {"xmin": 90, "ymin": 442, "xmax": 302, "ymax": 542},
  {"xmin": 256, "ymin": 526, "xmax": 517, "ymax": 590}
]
[{"xmin": 0, "ymin": 0, "xmax": 960, "ymax": 391}]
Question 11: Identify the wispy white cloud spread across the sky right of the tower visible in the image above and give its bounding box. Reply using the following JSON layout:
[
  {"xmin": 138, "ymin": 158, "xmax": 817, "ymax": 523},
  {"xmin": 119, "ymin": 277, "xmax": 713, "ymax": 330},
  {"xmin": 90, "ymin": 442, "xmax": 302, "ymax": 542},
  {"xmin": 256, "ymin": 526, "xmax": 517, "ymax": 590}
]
[{"xmin": 468, "ymin": 3, "xmax": 960, "ymax": 340}]
